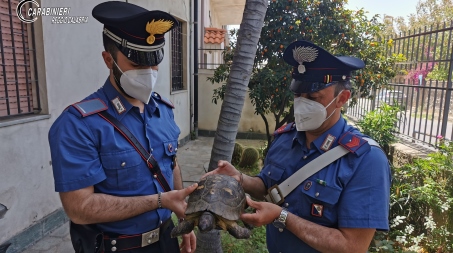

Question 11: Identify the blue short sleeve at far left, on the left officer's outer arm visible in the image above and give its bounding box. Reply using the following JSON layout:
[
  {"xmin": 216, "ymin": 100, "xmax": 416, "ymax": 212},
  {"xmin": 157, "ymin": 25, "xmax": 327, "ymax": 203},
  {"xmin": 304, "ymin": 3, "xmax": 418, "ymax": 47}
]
[{"xmin": 48, "ymin": 111, "xmax": 106, "ymax": 192}]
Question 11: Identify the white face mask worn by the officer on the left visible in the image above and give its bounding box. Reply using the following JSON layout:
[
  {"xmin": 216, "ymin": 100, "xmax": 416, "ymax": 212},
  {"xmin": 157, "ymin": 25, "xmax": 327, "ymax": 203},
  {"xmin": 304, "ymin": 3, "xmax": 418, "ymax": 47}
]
[{"xmin": 113, "ymin": 61, "xmax": 157, "ymax": 104}]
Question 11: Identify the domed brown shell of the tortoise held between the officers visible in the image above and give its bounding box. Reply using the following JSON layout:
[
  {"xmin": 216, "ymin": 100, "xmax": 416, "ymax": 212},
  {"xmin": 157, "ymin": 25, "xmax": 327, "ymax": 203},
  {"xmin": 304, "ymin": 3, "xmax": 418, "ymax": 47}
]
[{"xmin": 186, "ymin": 175, "xmax": 246, "ymax": 221}]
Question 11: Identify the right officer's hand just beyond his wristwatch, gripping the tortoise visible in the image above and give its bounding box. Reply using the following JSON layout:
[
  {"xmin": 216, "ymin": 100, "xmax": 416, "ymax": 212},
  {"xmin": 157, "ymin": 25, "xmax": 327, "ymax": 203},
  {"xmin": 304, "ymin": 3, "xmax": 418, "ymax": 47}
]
[{"xmin": 240, "ymin": 197, "xmax": 282, "ymax": 227}]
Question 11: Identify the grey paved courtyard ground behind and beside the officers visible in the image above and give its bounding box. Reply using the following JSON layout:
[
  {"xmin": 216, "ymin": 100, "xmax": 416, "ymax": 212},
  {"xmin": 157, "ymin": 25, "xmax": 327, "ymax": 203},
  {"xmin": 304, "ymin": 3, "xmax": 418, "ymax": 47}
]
[{"xmin": 23, "ymin": 137, "xmax": 264, "ymax": 253}]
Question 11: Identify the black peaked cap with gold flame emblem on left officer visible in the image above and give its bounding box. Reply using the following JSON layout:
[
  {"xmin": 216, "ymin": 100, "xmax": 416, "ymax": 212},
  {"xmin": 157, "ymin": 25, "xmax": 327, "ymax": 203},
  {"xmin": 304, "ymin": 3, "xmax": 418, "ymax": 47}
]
[{"xmin": 92, "ymin": 1, "xmax": 179, "ymax": 66}]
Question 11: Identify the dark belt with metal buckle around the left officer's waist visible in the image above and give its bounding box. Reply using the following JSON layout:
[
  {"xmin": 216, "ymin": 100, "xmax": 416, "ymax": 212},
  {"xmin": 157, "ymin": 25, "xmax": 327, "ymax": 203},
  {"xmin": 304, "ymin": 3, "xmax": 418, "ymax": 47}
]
[{"xmin": 104, "ymin": 218, "xmax": 173, "ymax": 252}]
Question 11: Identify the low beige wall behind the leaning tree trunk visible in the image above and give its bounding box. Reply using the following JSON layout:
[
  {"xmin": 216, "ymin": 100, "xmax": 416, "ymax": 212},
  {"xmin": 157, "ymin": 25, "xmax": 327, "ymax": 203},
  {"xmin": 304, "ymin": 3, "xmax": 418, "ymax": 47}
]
[{"xmin": 198, "ymin": 69, "xmax": 275, "ymax": 134}]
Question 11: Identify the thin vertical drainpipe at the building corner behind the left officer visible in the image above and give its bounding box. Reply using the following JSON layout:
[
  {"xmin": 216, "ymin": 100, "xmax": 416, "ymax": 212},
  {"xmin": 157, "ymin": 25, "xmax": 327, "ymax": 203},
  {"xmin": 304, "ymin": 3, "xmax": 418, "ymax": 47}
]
[{"xmin": 193, "ymin": 0, "xmax": 199, "ymax": 139}]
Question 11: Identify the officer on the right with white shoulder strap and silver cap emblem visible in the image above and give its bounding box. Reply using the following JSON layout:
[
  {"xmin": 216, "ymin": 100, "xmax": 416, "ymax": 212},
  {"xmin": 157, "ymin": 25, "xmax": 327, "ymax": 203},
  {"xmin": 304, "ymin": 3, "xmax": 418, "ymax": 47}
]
[{"xmin": 203, "ymin": 41, "xmax": 391, "ymax": 253}]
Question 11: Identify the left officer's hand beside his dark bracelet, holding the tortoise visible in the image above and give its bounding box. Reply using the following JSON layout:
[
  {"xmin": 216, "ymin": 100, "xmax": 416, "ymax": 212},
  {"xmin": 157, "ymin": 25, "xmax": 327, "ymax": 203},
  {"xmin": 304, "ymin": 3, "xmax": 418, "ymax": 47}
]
[{"xmin": 161, "ymin": 183, "xmax": 198, "ymax": 218}]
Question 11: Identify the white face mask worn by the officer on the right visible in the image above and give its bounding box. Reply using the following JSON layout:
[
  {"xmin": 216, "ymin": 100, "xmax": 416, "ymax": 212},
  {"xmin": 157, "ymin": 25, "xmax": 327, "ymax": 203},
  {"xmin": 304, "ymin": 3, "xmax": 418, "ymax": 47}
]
[{"xmin": 294, "ymin": 91, "xmax": 343, "ymax": 131}]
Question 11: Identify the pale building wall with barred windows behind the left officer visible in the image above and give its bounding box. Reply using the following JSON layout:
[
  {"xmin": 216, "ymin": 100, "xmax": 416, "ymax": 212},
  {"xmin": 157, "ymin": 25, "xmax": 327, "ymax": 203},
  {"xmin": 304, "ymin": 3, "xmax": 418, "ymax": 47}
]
[{"xmin": 0, "ymin": 0, "xmax": 191, "ymax": 244}]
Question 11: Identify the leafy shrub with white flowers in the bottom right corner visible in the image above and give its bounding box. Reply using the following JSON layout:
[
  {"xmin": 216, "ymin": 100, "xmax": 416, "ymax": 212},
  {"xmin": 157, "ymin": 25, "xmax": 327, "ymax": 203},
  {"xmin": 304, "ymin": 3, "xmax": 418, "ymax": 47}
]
[{"xmin": 378, "ymin": 138, "xmax": 453, "ymax": 253}]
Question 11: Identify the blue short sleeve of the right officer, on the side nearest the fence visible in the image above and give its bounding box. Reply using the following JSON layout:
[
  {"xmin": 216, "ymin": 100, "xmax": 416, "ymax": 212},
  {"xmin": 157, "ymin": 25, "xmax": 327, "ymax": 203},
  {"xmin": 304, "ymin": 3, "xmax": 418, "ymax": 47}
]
[{"xmin": 338, "ymin": 146, "xmax": 391, "ymax": 231}]
